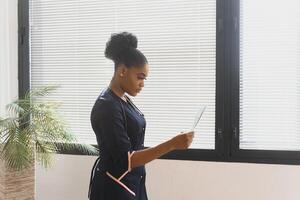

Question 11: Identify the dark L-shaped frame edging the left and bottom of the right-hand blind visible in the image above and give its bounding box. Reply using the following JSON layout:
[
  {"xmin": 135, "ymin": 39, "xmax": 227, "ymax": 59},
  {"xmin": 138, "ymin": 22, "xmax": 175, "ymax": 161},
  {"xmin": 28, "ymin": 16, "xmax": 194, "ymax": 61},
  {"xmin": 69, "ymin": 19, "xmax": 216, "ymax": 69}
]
[{"xmin": 229, "ymin": 0, "xmax": 300, "ymax": 165}]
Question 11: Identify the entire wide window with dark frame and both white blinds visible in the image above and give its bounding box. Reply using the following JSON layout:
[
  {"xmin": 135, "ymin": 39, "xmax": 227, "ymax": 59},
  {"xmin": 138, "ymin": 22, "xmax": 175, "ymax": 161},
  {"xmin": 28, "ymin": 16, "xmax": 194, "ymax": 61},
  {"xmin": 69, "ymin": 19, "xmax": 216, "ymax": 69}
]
[{"xmin": 19, "ymin": 0, "xmax": 300, "ymax": 164}]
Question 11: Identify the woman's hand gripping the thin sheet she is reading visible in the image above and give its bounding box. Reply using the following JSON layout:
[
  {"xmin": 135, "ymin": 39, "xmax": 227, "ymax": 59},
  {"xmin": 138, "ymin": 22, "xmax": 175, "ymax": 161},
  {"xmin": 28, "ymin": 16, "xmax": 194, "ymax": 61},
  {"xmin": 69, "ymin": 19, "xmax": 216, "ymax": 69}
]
[{"xmin": 171, "ymin": 131, "xmax": 194, "ymax": 150}]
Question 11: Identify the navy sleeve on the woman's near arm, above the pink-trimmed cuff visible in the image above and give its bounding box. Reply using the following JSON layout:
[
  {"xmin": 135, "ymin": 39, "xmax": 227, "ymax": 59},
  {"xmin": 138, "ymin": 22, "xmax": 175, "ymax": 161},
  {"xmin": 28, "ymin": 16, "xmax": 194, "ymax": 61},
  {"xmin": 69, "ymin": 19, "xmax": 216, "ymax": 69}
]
[{"xmin": 92, "ymin": 99, "xmax": 132, "ymax": 167}]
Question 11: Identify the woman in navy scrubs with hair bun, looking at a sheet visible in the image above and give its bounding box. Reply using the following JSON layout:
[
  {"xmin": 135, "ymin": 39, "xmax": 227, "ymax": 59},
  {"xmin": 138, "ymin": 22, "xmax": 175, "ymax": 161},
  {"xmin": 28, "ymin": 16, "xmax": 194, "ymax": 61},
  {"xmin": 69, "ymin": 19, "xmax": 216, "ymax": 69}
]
[{"xmin": 89, "ymin": 32, "xmax": 194, "ymax": 200}]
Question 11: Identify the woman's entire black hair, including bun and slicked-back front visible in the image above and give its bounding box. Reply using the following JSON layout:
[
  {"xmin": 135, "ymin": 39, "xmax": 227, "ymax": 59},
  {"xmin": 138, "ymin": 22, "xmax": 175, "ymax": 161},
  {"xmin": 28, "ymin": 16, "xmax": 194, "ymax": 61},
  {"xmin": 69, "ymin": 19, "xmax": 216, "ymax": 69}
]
[{"xmin": 104, "ymin": 32, "xmax": 148, "ymax": 68}]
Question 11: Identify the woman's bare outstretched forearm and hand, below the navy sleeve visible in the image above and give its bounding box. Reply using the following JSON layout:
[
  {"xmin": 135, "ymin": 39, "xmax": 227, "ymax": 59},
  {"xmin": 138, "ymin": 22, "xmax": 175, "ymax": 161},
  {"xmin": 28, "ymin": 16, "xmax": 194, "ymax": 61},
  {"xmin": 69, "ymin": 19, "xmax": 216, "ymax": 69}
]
[{"xmin": 131, "ymin": 132, "xmax": 194, "ymax": 168}]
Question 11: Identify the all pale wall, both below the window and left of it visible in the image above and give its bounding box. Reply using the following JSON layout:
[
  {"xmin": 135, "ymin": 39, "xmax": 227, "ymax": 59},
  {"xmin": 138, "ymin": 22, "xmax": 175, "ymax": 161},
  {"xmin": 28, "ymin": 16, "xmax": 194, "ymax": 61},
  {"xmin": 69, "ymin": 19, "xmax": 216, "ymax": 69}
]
[{"xmin": 0, "ymin": 0, "xmax": 300, "ymax": 200}]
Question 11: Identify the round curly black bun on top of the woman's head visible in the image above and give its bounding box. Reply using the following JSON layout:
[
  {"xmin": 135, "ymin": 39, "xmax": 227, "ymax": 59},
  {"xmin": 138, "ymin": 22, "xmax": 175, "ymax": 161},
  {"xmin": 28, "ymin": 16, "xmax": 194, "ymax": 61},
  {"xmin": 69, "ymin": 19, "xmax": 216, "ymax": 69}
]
[{"xmin": 104, "ymin": 32, "xmax": 137, "ymax": 61}]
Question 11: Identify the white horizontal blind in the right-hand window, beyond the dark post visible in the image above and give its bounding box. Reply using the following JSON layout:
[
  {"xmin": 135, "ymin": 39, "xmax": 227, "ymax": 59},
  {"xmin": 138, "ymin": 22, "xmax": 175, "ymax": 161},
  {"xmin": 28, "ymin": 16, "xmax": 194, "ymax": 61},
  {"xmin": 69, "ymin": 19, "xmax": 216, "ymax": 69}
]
[{"xmin": 240, "ymin": 0, "xmax": 300, "ymax": 150}]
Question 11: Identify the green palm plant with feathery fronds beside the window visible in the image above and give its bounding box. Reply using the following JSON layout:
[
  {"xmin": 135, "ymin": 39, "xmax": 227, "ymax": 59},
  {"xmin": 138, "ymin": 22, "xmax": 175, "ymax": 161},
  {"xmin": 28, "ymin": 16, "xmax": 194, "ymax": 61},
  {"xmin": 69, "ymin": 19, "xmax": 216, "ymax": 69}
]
[{"xmin": 0, "ymin": 86, "xmax": 97, "ymax": 171}]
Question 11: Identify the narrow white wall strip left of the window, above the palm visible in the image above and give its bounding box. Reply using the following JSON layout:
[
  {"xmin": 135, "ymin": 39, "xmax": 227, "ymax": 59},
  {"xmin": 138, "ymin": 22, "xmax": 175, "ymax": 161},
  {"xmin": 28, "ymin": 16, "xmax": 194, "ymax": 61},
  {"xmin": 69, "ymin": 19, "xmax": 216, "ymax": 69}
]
[{"xmin": 0, "ymin": 0, "xmax": 18, "ymax": 117}]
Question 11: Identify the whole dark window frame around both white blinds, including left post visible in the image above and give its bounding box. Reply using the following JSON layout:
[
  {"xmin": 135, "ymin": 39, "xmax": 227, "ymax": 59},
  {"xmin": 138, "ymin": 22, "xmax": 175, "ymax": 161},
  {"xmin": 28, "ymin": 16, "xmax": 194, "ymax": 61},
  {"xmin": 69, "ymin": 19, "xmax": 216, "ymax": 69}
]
[{"xmin": 18, "ymin": 0, "xmax": 300, "ymax": 165}]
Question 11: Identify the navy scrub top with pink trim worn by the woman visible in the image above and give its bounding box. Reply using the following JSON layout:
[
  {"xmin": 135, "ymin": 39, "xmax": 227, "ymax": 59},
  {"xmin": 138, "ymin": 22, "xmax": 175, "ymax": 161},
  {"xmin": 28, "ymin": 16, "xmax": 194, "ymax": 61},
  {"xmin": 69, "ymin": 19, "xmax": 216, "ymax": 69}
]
[{"xmin": 89, "ymin": 88, "xmax": 148, "ymax": 200}]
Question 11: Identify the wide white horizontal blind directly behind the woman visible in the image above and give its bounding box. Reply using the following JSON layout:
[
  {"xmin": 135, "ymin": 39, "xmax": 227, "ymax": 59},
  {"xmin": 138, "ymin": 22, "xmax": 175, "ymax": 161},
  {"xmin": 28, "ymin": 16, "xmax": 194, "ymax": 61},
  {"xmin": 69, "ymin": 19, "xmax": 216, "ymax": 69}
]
[{"xmin": 30, "ymin": 0, "xmax": 216, "ymax": 149}]
